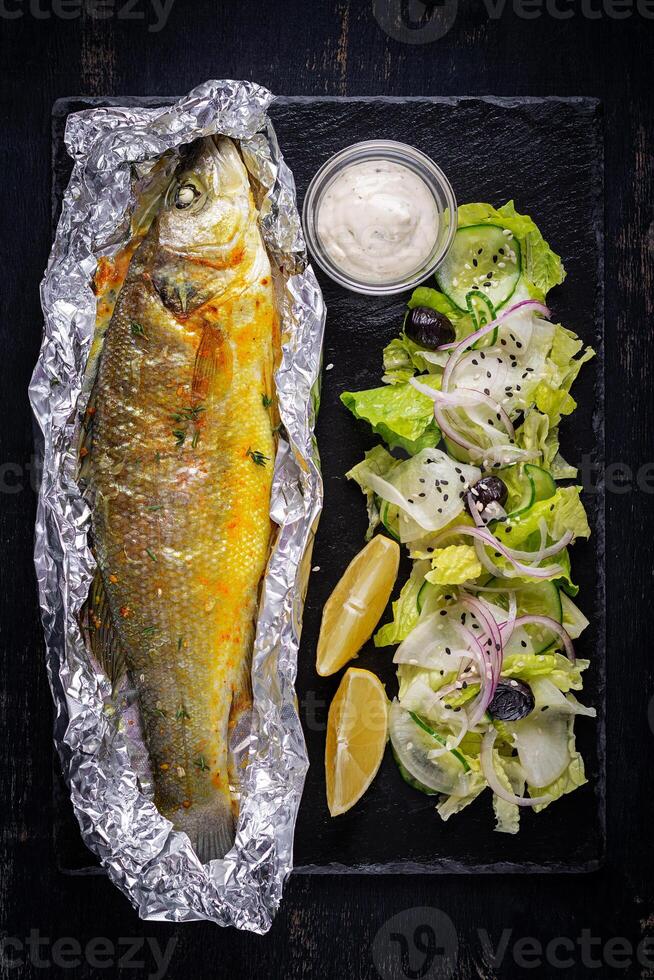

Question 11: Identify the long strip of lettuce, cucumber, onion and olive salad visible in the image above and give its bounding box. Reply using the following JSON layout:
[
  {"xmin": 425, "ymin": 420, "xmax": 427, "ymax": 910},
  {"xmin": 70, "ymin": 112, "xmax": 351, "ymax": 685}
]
[{"xmin": 341, "ymin": 202, "xmax": 595, "ymax": 833}]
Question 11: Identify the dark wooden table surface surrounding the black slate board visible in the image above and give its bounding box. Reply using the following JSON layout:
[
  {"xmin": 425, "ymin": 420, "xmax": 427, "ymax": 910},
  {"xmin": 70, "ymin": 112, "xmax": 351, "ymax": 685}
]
[{"xmin": 0, "ymin": 0, "xmax": 654, "ymax": 980}]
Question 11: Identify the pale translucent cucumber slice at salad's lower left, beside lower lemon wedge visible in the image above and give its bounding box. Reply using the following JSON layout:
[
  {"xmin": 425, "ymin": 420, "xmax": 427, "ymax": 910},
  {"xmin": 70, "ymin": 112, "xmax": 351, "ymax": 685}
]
[{"xmin": 389, "ymin": 701, "xmax": 466, "ymax": 796}]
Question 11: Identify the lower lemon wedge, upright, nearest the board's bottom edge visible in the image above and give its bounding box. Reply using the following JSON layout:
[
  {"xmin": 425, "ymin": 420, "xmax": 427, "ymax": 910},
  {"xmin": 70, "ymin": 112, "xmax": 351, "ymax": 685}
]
[{"xmin": 325, "ymin": 667, "xmax": 388, "ymax": 817}]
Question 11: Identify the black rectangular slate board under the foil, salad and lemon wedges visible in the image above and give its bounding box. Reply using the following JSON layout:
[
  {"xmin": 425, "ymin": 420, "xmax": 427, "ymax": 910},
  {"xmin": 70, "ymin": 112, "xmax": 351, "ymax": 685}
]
[{"xmin": 53, "ymin": 97, "xmax": 605, "ymax": 873}]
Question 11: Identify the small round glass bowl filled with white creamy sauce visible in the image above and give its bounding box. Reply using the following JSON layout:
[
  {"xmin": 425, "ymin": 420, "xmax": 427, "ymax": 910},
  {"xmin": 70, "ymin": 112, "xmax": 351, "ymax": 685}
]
[{"xmin": 303, "ymin": 140, "xmax": 457, "ymax": 296}]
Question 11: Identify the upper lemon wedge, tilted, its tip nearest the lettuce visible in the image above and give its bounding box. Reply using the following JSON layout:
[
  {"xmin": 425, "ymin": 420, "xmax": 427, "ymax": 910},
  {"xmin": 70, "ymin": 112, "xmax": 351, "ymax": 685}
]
[{"xmin": 316, "ymin": 535, "xmax": 400, "ymax": 677}]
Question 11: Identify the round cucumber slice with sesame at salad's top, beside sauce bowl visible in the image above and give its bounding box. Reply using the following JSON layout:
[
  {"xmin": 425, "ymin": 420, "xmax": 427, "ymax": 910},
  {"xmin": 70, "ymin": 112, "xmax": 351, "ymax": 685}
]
[{"xmin": 436, "ymin": 225, "xmax": 522, "ymax": 310}]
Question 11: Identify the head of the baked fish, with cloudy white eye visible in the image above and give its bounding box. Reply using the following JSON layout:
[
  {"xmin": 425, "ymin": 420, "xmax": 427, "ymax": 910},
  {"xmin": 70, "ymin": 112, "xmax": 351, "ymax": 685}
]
[{"xmin": 150, "ymin": 136, "xmax": 256, "ymax": 316}]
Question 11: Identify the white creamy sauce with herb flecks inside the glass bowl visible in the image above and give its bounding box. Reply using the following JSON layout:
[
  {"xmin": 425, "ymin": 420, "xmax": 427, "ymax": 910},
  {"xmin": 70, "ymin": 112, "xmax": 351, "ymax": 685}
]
[{"xmin": 316, "ymin": 160, "xmax": 439, "ymax": 283}]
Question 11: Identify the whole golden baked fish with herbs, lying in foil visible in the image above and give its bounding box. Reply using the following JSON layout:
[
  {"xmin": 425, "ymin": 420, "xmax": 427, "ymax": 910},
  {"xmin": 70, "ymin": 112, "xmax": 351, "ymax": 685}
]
[{"xmin": 82, "ymin": 138, "xmax": 276, "ymax": 861}]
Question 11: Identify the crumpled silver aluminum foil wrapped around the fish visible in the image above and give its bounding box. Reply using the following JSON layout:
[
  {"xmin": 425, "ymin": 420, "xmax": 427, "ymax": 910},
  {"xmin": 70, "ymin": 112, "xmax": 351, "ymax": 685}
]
[{"xmin": 30, "ymin": 81, "xmax": 325, "ymax": 933}]
